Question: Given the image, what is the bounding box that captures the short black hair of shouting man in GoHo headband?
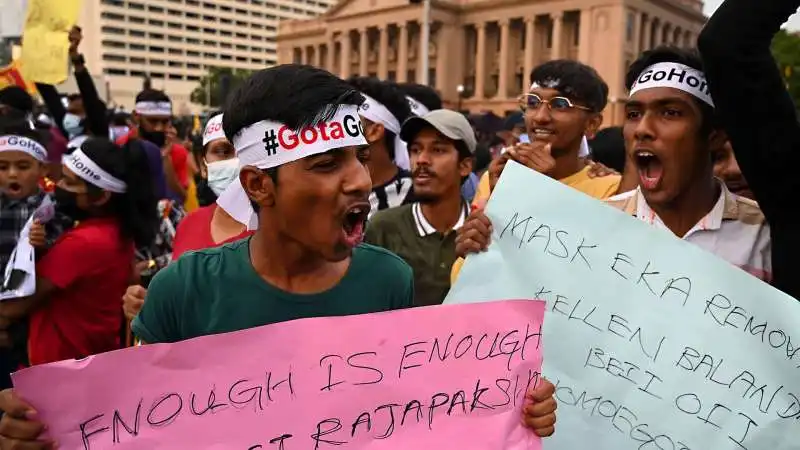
[625,45,722,136]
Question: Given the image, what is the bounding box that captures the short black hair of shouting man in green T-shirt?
[222,64,364,185]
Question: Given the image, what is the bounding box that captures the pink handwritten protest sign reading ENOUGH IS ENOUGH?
[13,300,544,450]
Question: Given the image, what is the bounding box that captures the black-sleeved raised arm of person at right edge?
[698,0,800,299]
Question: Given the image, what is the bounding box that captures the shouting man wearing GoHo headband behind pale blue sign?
[609,47,772,281]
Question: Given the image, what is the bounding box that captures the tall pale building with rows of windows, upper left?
[78,0,334,114]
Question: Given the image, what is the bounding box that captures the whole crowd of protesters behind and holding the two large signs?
[0,0,800,449]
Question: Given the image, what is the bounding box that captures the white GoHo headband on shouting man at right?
[630,62,714,107]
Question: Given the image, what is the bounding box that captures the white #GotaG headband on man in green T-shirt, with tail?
[217,105,368,230]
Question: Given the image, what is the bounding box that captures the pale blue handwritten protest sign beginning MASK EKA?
[445,163,800,450]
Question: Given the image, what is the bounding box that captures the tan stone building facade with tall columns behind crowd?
[278,0,706,125]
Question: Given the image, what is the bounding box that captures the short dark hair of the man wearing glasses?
[530,59,608,113]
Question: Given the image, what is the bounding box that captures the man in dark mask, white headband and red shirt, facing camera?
[117,89,189,204]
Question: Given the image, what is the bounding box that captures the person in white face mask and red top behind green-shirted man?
[122,114,252,320]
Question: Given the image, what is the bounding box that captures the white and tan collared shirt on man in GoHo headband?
[606,183,772,282]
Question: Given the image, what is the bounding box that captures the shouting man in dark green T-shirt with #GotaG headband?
[132,65,413,343]
